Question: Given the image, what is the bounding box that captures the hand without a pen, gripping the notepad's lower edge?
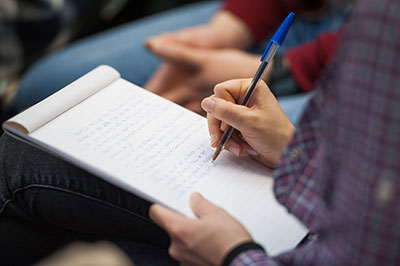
[149,193,251,265]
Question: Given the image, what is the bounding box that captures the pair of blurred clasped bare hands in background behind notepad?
[145,11,272,114]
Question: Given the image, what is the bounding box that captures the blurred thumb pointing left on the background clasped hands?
[147,38,201,66]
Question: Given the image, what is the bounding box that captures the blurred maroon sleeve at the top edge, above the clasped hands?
[223,0,318,42]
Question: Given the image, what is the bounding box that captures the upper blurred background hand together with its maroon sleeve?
[148,0,325,49]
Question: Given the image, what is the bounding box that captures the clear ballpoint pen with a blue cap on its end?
[212,12,294,161]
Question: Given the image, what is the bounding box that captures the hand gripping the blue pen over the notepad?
[201,79,295,167]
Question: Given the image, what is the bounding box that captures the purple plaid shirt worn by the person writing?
[231,0,400,266]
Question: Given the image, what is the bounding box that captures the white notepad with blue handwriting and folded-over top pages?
[3,66,307,255]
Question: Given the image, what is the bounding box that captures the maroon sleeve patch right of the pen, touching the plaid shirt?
[285,31,341,91]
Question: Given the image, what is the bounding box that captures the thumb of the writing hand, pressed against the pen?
[201,97,249,131]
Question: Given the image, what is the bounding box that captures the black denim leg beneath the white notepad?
[0,135,169,265]
